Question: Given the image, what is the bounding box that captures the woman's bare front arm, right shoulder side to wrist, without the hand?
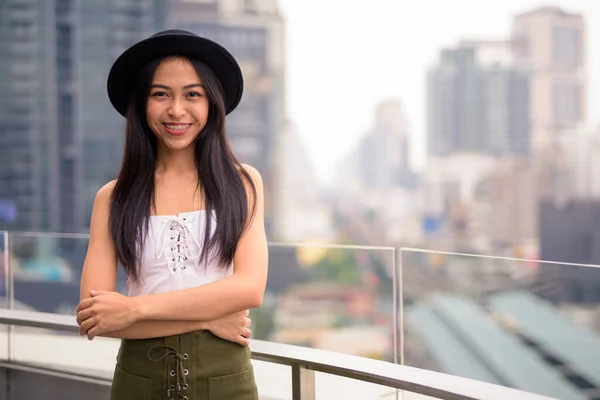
[133,167,268,321]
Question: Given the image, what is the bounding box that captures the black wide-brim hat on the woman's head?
[107,29,244,117]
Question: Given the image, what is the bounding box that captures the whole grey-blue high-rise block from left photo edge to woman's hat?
[0,0,168,232]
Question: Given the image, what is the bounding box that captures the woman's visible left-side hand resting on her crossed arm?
[77,290,137,340]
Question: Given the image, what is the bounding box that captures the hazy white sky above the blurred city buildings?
[279,0,600,184]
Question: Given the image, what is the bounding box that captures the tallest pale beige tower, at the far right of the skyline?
[512,7,587,145]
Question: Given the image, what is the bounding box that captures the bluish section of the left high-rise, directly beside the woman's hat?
[75,0,169,226]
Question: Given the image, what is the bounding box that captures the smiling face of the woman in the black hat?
[146,57,209,150]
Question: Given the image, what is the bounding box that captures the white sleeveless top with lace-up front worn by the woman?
[127,210,233,296]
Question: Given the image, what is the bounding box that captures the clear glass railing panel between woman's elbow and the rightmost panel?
[258,244,397,362]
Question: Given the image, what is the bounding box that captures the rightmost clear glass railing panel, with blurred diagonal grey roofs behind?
[399,250,600,400]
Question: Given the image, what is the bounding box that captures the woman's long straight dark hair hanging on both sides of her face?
[109,57,256,281]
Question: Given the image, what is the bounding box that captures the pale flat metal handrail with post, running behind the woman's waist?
[0,310,551,400]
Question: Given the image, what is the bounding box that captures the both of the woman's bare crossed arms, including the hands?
[77,168,268,341]
